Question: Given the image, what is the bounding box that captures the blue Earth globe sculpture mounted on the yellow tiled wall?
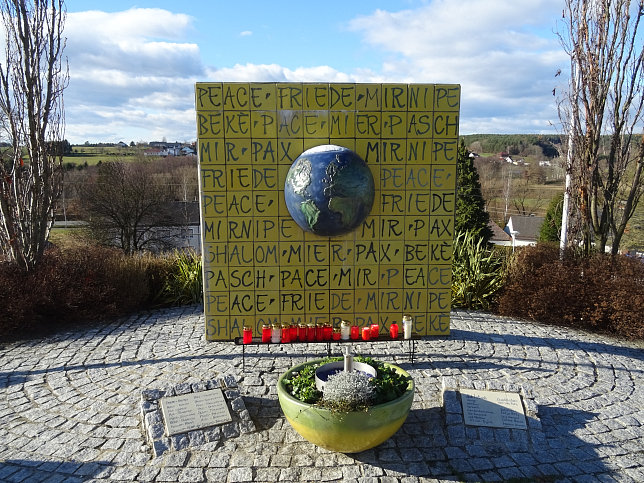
[284,144,374,236]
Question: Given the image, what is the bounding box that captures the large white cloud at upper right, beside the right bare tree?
[349,0,566,132]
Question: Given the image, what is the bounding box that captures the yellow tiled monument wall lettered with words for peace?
[195,82,460,340]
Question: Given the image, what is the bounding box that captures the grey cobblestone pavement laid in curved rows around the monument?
[0,307,644,482]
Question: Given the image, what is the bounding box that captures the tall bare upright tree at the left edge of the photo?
[0,0,69,270]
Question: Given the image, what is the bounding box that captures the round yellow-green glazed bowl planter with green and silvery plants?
[277,357,414,453]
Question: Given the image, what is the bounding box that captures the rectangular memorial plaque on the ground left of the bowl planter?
[161,389,232,436]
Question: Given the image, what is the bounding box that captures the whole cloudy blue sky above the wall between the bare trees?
[65,0,568,143]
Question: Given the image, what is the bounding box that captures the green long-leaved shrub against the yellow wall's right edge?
[452,231,505,310]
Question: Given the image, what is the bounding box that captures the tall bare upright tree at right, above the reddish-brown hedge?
[559,0,644,254]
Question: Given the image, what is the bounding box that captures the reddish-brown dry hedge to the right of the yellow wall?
[498,244,644,339]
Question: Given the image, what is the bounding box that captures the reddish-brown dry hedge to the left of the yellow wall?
[0,245,172,338]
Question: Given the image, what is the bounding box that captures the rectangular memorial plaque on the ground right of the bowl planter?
[460,389,527,429]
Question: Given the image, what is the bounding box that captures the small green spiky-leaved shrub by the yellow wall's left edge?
[160,251,203,305]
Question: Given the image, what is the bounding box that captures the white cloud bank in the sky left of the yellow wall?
[65,8,204,143]
